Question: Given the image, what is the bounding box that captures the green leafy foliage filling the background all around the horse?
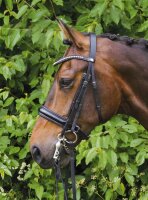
[0,0,148,200]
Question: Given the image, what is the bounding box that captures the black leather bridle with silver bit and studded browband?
[39,33,102,199]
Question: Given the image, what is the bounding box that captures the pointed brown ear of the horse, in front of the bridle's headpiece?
[58,19,89,48]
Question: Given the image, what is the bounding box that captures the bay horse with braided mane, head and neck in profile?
[30,20,148,168]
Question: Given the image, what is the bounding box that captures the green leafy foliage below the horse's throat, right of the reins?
[77,116,148,200]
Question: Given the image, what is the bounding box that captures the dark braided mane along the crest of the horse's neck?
[98,33,148,49]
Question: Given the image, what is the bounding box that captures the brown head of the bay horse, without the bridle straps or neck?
[30,21,148,168]
